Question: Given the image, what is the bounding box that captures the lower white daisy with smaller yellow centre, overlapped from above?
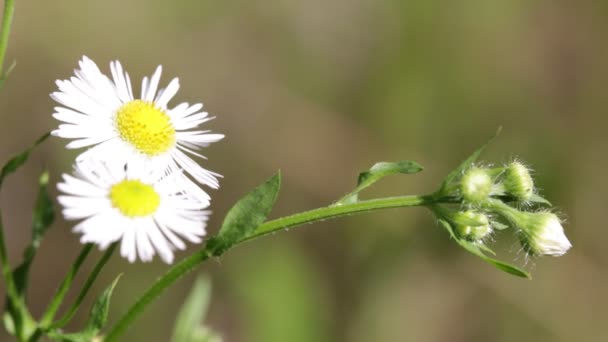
[57,160,209,263]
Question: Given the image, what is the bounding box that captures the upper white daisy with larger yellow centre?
[51,56,224,201]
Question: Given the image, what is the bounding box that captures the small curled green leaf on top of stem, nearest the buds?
[333,160,423,205]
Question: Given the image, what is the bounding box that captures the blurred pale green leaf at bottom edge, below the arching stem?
[171,275,211,342]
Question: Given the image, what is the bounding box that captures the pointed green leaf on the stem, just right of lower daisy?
[205,172,281,256]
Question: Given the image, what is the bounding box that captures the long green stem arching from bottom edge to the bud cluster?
[104,196,444,342]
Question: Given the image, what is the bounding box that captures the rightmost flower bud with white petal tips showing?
[517,212,572,256]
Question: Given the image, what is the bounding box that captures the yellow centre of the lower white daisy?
[110,180,160,217]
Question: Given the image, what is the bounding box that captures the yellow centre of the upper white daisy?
[116,100,175,156]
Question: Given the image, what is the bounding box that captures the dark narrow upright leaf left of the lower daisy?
[13,171,55,295]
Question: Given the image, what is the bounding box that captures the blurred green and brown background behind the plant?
[0,0,608,342]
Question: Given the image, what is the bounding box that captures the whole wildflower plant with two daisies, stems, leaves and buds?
[0,0,571,342]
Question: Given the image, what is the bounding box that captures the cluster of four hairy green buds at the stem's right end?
[441,161,572,256]
